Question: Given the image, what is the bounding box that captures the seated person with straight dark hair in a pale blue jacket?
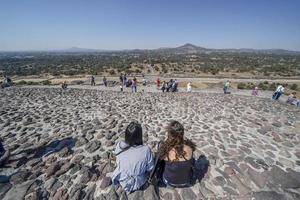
[112,122,154,193]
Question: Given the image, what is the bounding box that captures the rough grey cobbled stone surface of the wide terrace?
[0,86,300,200]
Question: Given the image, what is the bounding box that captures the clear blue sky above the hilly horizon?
[0,0,300,51]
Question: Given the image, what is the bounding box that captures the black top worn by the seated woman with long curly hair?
[163,158,194,185]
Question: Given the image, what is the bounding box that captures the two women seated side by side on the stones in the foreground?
[112,120,209,193]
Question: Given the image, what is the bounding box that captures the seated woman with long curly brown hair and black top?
[160,120,203,187]
